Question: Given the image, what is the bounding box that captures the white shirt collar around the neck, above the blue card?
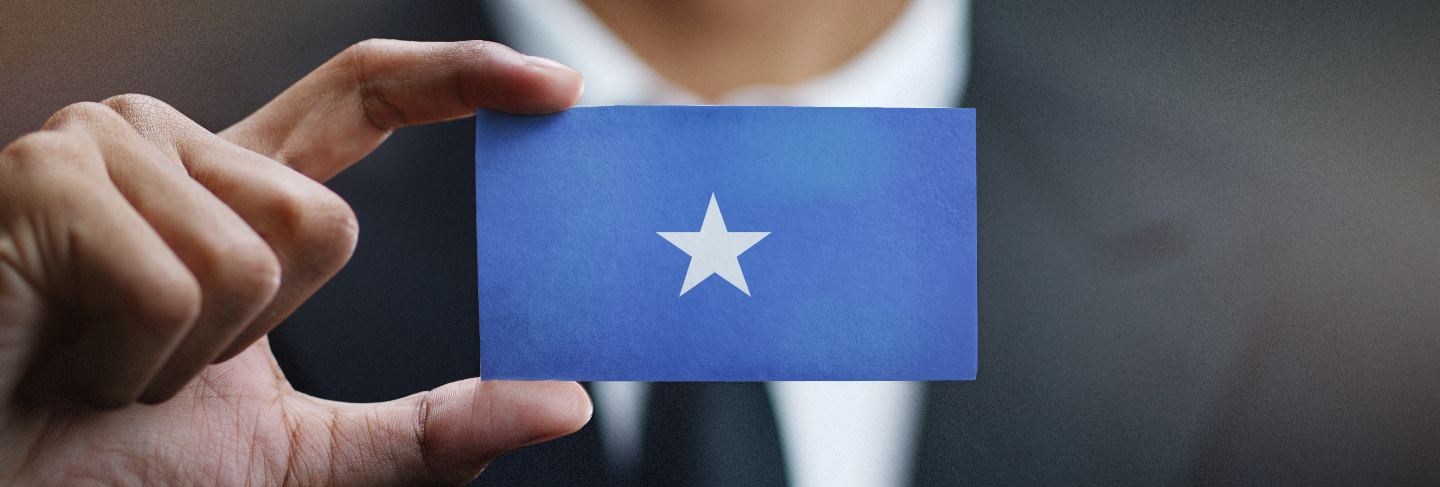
[492,0,969,107]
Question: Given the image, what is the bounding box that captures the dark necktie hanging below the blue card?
[634,382,786,487]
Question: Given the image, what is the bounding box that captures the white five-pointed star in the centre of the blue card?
[655,193,770,295]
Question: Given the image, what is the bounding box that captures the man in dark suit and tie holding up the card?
[0,1,1440,486]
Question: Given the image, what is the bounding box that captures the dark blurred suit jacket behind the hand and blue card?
[160,0,1440,486]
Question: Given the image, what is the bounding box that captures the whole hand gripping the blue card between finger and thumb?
[0,40,590,486]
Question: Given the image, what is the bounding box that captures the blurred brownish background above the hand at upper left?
[0,0,475,136]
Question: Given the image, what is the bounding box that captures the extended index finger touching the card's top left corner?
[220,39,583,180]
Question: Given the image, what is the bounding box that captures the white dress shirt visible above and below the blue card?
[492,0,969,487]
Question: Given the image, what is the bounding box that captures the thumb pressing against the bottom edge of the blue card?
[308,379,592,486]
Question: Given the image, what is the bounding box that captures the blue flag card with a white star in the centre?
[475,107,976,380]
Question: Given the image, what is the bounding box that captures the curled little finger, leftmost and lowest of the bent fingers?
[4,130,200,406]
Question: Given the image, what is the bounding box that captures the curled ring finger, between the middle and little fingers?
[50,95,281,403]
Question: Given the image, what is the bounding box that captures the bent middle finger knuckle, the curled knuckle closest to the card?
[275,183,360,274]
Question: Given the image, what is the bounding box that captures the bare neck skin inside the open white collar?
[582,0,907,101]
